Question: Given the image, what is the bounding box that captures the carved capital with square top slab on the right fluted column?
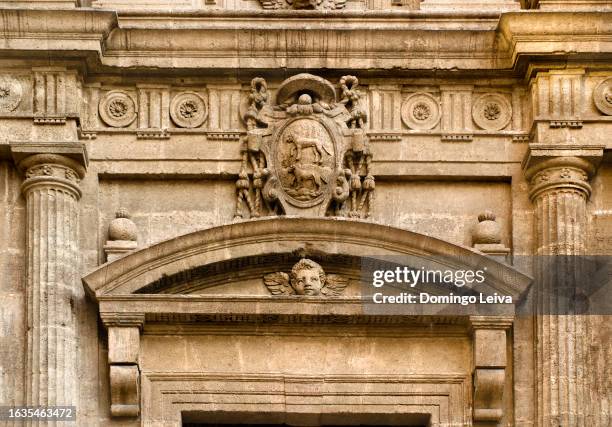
[523,144,604,200]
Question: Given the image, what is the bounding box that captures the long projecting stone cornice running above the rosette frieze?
[0,9,612,74]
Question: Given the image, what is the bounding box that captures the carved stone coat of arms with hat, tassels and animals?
[236,74,375,218]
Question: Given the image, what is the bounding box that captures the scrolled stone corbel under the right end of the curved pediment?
[470,316,512,423]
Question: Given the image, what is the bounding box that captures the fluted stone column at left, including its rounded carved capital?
[19,154,85,424]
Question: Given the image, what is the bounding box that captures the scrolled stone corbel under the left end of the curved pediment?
[100,313,144,417]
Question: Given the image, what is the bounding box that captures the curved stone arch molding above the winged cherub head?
[83,217,529,301]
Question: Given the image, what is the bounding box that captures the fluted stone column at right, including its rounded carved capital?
[525,156,599,427]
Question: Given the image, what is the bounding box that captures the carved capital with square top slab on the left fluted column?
[10,142,88,200]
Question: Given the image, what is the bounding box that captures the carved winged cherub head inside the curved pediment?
[264,259,348,296]
